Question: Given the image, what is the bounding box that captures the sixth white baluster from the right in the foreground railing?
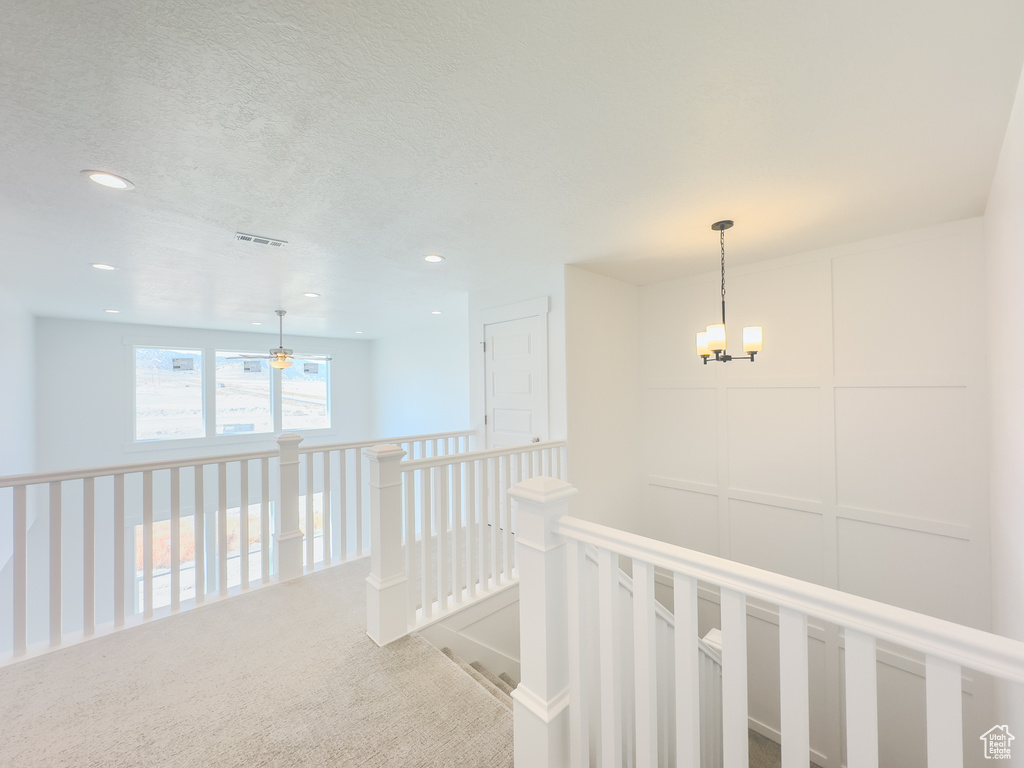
[633,559,657,768]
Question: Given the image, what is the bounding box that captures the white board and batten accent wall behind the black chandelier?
[634,219,990,766]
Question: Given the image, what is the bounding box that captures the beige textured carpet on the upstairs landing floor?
[0,559,512,768]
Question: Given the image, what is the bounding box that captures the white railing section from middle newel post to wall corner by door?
[366,440,567,645]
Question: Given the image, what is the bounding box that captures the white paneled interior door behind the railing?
[483,315,548,447]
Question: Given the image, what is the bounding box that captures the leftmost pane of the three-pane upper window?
[135,347,206,440]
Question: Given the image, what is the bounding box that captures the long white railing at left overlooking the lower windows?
[0,431,472,664]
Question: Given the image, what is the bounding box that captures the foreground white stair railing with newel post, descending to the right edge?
[510,477,1024,768]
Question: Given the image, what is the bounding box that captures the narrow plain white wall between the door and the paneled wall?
[565,266,641,530]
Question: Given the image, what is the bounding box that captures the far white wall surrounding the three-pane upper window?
[36,317,374,471]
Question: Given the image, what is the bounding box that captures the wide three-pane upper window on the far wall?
[132,345,331,442]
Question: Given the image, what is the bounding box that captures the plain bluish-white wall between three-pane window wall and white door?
[370,298,470,437]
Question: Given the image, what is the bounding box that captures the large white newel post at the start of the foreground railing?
[509,477,578,768]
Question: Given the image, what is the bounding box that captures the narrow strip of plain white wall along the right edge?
[985,60,1024,738]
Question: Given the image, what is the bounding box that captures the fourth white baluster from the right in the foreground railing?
[722,588,749,768]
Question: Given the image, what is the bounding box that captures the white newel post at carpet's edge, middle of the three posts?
[365,445,409,645]
